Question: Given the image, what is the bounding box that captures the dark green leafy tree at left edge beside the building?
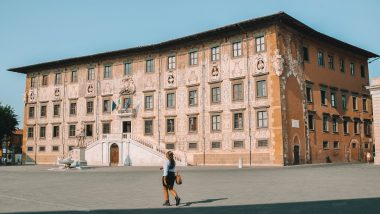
[0,103,18,142]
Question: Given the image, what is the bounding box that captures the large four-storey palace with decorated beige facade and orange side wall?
[9,12,378,165]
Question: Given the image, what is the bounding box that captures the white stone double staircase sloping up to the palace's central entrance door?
[86,133,187,166]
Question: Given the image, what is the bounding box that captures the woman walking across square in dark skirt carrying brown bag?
[162,151,181,206]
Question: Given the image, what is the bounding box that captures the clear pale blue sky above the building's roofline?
[0,0,380,127]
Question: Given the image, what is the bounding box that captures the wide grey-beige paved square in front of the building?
[0,164,380,214]
